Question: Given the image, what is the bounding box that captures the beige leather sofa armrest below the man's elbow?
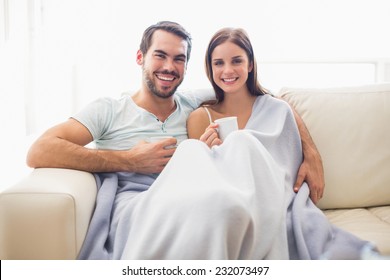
[0,168,97,259]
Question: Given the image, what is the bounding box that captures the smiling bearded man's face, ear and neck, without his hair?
[132,30,188,122]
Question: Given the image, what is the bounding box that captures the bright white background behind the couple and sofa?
[0,0,390,188]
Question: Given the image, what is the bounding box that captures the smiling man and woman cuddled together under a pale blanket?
[28,21,374,259]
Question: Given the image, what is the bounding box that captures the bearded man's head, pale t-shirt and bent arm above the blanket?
[27,22,201,174]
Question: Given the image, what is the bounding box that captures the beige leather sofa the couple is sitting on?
[0,84,390,259]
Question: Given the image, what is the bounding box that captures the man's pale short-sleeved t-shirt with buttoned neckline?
[73,92,209,150]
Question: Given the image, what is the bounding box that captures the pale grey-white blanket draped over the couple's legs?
[79,96,372,259]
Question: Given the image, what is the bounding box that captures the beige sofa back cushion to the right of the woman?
[279,84,390,209]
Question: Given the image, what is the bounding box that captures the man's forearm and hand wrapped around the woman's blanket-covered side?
[292,108,325,203]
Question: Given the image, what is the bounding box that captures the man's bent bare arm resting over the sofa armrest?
[27,119,175,173]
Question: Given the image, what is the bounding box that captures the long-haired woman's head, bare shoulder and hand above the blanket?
[187,28,267,147]
